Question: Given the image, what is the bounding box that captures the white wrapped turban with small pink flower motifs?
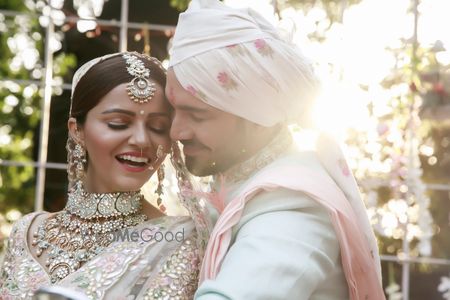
[169,0,317,127]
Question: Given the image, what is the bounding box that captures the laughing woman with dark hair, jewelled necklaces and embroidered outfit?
[0,52,208,299]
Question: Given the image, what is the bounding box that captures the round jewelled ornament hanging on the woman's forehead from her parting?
[122,53,156,103]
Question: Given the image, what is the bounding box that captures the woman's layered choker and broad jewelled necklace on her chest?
[32,181,147,283]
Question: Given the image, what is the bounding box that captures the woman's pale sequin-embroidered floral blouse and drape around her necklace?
[0,212,199,300]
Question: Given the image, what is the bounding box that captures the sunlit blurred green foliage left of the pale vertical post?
[0,0,43,218]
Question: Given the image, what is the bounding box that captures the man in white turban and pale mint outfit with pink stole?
[166,0,384,300]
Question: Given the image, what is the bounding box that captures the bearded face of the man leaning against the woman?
[166,69,249,176]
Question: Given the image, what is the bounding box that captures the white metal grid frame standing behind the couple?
[0,0,450,300]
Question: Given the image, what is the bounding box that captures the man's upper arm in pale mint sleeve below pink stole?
[195,193,348,300]
